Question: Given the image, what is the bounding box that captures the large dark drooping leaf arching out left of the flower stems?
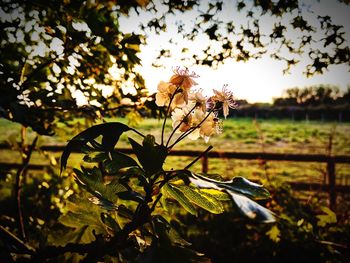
[61,122,130,173]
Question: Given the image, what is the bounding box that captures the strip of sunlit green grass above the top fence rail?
[0,119,350,155]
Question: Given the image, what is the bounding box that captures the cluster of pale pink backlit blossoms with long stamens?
[156,67,235,145]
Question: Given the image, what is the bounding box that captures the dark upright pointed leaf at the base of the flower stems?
[129,135,168,175]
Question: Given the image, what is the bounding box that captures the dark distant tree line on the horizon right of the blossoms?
[232,85,350,122]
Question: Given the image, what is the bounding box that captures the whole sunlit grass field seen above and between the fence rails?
[0,119,350,190]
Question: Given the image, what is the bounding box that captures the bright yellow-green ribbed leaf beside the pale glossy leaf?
[174,185,224,214]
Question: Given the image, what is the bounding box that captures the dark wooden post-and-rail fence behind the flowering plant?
[0,144,350,209]
